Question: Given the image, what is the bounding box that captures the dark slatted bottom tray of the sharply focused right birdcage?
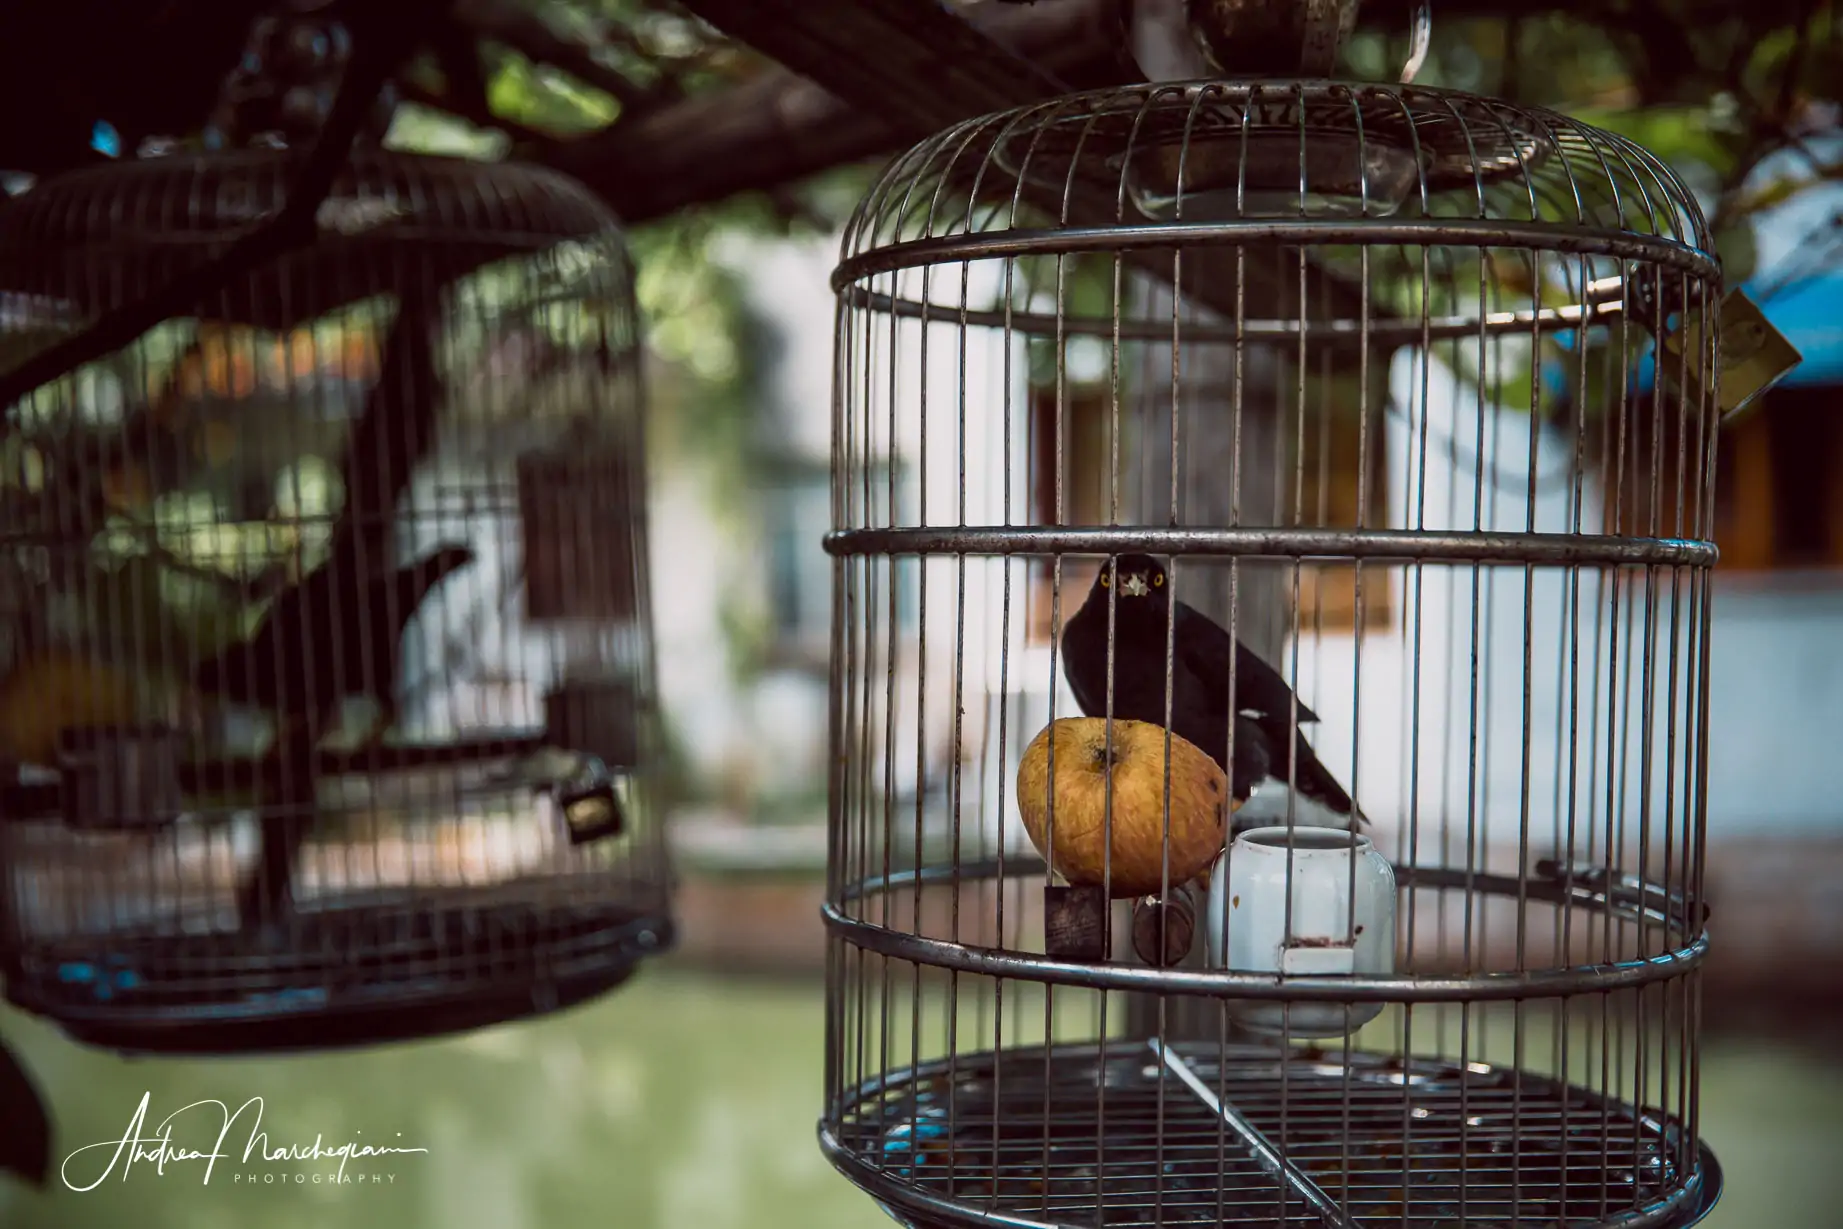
[820,1041,1721,1229]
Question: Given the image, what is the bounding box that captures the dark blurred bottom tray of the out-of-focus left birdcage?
[6,890,673,1054]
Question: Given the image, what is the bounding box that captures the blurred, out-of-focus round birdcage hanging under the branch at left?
[0,149,673,1050]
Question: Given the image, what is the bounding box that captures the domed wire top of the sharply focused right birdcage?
[837,81,1716,341]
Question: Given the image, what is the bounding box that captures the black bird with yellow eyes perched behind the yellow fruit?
[1062,555,1362,822]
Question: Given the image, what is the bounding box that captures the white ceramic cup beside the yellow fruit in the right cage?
[1205,827,1395,1037]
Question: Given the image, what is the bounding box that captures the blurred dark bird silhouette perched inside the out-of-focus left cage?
[192,545,474,732]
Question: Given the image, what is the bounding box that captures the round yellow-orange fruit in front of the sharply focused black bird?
[1017,717,1235,897]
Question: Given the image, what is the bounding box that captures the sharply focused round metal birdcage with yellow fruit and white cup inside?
[820,81,1721,1229]
